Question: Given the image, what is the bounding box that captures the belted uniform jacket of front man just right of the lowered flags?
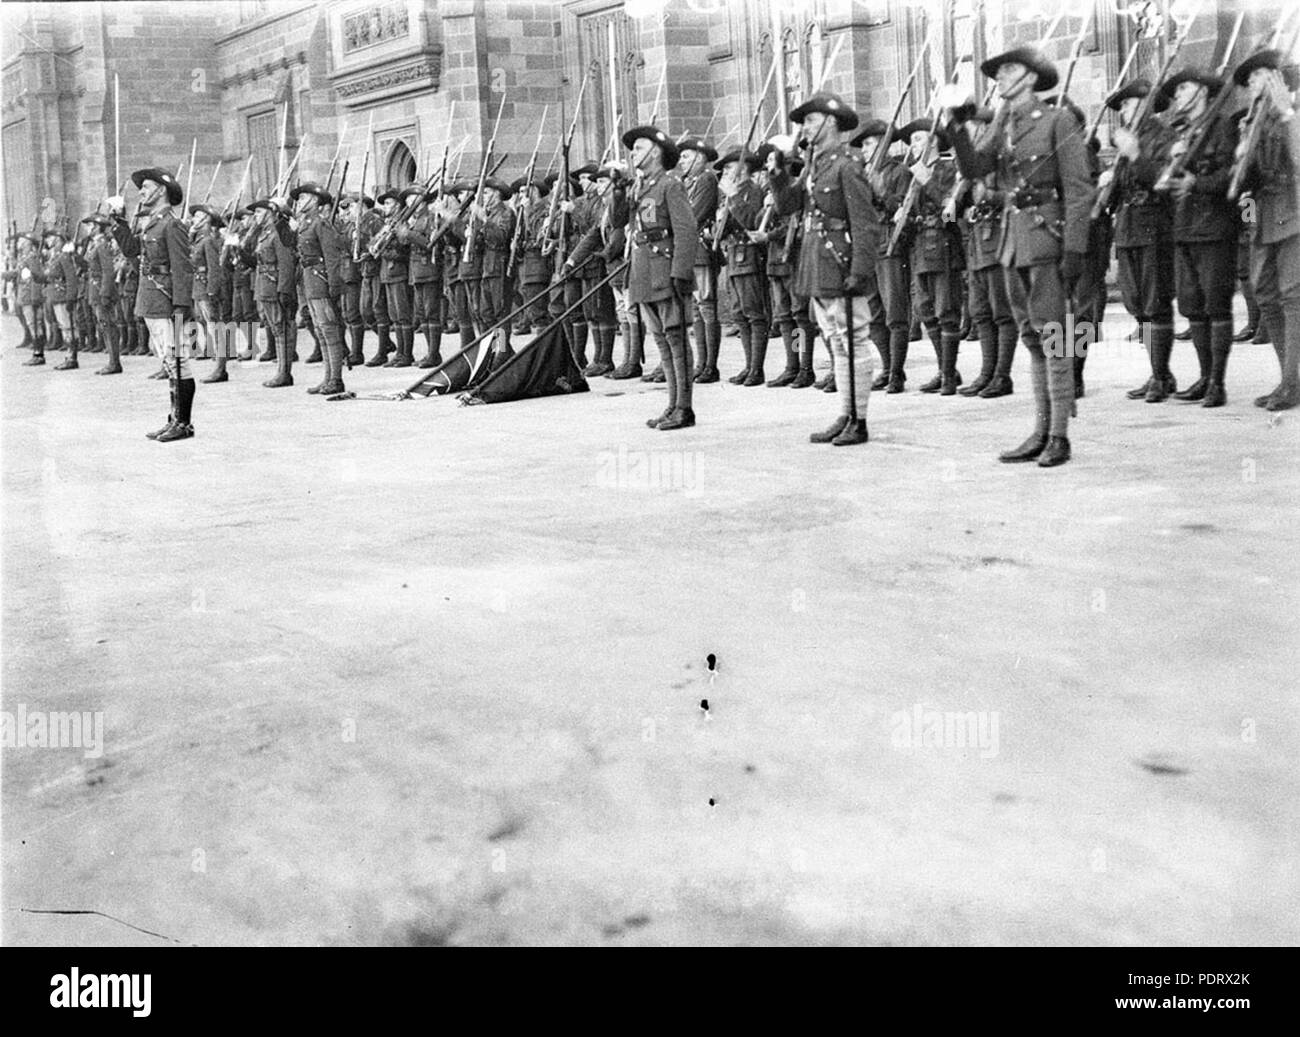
[628,170,699,303]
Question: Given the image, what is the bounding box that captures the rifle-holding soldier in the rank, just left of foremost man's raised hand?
[894,118,963,396]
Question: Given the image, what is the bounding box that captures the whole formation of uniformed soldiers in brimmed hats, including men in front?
[5,30,1300,467]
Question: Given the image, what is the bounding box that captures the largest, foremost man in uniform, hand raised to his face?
[944,47,1092,468]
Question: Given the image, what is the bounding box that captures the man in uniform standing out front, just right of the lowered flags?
[623,126,699,431]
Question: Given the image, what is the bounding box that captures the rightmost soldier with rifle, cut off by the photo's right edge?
[1232,51,1300,411]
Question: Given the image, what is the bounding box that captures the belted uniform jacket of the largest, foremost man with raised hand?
[953,97,1093,266]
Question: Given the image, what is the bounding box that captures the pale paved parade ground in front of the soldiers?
[0,316,1300,945]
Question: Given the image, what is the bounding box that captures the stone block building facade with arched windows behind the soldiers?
[0,0,1282,225]
